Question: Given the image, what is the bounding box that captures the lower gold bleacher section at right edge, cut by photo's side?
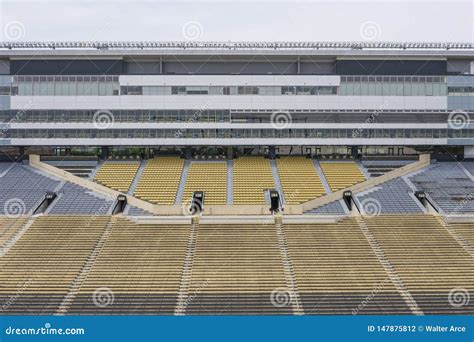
[365,215,474,315]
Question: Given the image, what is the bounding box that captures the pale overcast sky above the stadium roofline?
[0,0,474,42]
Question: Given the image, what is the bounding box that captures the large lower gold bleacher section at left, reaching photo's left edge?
[0,216,110,315]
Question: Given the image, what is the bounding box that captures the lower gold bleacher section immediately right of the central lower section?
[284,219,410,315]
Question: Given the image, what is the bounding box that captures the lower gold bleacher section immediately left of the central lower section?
[68,219,191,315]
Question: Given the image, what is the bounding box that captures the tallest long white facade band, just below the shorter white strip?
[11,95,447,110]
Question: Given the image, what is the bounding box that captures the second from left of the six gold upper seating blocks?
[134,157,184,205]
